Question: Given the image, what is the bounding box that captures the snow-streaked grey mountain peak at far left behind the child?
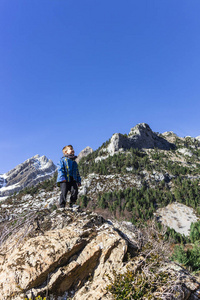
[0,155,56,197]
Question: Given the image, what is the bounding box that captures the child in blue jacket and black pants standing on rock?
[57,145,81,207]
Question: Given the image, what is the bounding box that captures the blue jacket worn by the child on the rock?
[57,156,81,186]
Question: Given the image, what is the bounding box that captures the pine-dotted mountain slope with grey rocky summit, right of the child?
[79,123,200,233]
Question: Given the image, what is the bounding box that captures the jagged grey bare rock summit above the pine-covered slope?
[107,123,175,154]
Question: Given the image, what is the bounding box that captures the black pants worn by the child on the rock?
[60,180,78,207]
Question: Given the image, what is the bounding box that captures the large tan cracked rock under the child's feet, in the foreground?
[0,209,137,300]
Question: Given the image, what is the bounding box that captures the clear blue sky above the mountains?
[0,0,200,173]
